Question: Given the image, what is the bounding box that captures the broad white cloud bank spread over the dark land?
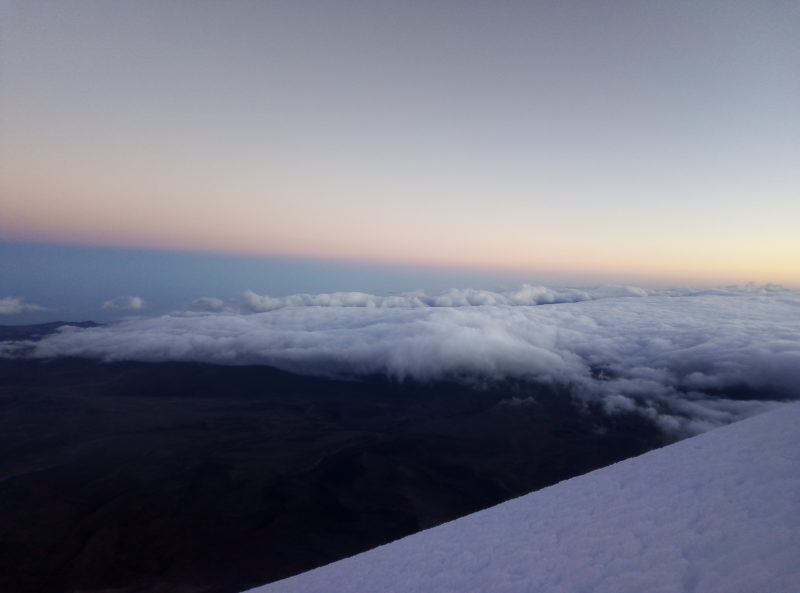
[0,286,800,433]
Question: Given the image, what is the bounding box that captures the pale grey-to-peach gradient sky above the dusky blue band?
[0,0,800,286]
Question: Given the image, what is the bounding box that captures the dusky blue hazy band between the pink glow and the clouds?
[0,243,585,323]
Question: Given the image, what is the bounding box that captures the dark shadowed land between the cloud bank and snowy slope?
[0,358,665,593]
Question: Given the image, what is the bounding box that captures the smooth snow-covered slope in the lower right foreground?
[247,404,800,593]
